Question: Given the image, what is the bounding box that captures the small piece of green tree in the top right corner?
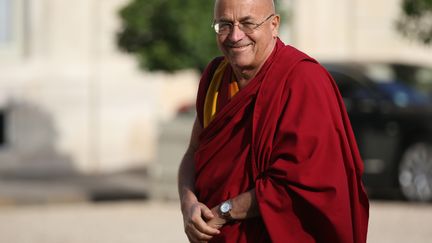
[396,0,432,44]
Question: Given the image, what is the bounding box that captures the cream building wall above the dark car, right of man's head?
[283,0,432,65]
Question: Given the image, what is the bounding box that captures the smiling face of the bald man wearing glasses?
[214,0,279,73]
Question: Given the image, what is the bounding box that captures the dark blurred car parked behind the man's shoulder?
[323,62,432,201]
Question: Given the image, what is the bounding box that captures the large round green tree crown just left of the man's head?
[117,0,219,72]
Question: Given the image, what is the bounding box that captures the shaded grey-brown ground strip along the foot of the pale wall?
[0,169,149,205]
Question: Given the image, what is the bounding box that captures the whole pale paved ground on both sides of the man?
[0,201,432,243]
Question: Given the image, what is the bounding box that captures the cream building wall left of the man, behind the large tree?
[0,0,198,173]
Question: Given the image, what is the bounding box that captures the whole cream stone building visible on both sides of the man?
[0,0,432,174]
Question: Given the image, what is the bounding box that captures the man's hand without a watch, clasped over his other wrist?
[182,196,220,242]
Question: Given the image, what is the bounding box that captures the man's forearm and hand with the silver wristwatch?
[207,189,260,228]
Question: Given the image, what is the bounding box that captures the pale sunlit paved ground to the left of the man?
[0,201,186,243]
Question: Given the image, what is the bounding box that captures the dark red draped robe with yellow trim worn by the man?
[195,40,369,243]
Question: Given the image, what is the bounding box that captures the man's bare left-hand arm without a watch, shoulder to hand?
[178,119,219,242]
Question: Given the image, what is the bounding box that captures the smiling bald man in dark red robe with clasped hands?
[178,0,369,243]
